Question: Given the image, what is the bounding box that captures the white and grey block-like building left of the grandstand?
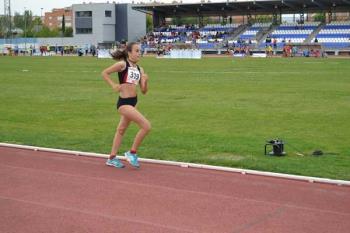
[72,3,146,45]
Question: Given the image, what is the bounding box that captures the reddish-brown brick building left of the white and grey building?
[44,7,73,29]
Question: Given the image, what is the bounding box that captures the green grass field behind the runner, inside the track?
[0,57,350,180]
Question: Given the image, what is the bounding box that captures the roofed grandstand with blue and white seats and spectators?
[133,0,350,54]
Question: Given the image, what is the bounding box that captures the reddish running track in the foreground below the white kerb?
[0,147,350,233]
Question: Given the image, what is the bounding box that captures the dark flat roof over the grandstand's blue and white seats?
[132,0,350,17]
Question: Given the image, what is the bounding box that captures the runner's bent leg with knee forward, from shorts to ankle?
[119,105,151,151]
